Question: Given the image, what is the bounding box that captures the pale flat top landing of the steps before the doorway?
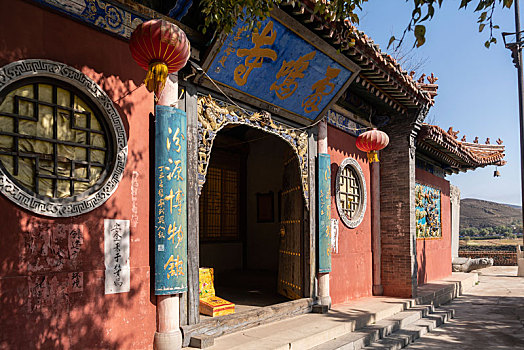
[186,273,478,350]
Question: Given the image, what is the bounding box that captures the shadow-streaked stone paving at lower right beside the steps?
[406,266,524,350]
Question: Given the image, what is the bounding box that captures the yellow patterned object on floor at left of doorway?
[198,267,235,317]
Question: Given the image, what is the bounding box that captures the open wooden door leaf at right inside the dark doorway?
[277,153,304,299]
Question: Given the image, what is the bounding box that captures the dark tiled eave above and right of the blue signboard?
[280,0,438,114]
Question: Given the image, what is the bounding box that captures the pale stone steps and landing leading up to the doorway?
[184,273,478,350]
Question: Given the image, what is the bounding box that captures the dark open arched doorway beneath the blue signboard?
[199,125,304,313]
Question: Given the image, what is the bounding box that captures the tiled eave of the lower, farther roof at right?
[417,124,506,173]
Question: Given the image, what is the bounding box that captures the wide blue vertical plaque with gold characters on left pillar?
[155,106,187,295]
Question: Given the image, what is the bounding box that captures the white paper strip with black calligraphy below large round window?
[104,219,130,294]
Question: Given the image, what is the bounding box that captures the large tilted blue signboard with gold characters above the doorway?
[207,17,352,120]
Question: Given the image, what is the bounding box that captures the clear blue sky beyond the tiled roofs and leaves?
[359,0,524,205]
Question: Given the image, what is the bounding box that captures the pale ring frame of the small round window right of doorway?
[335,158,367,228]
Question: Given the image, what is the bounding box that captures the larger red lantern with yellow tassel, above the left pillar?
[129,19,191,95]
